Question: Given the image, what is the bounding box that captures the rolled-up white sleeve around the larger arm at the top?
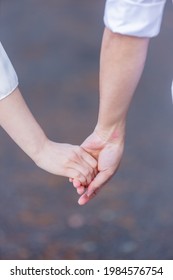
[104,0,166,37]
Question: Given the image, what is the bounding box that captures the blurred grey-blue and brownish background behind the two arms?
[0,0,173,260]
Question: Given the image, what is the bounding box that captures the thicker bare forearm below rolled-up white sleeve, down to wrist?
[96,28,149,140]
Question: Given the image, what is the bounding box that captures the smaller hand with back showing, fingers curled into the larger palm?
[35,138,97,185]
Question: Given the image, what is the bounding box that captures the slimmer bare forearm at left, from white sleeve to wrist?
[0,88,47,161]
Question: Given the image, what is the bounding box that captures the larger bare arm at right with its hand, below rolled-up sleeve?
[73,28,149,205]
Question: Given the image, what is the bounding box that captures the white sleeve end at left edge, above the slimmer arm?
[0,42,18,100]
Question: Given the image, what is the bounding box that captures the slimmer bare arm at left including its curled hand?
[0,88,97,185]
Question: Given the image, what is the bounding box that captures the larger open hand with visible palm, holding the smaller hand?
[73,131,124,205]
